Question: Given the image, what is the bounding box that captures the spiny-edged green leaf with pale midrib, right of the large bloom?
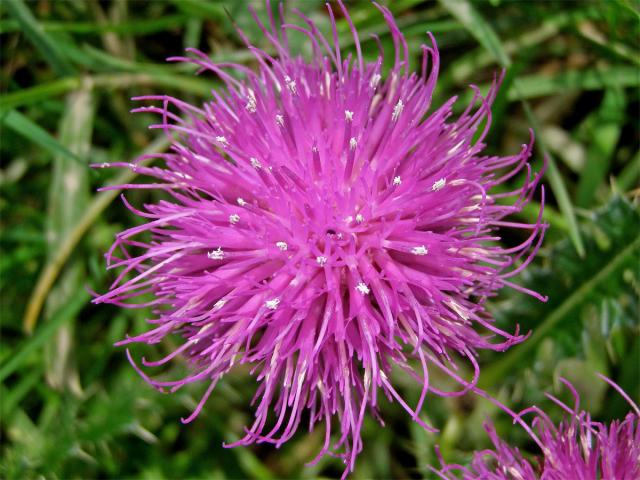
[481,197,640,386]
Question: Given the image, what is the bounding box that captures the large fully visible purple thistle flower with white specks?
[94,3,546,473]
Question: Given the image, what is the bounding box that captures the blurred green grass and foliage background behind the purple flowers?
[0,0,640,479]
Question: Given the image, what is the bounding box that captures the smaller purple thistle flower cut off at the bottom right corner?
[434,375,640,480]
